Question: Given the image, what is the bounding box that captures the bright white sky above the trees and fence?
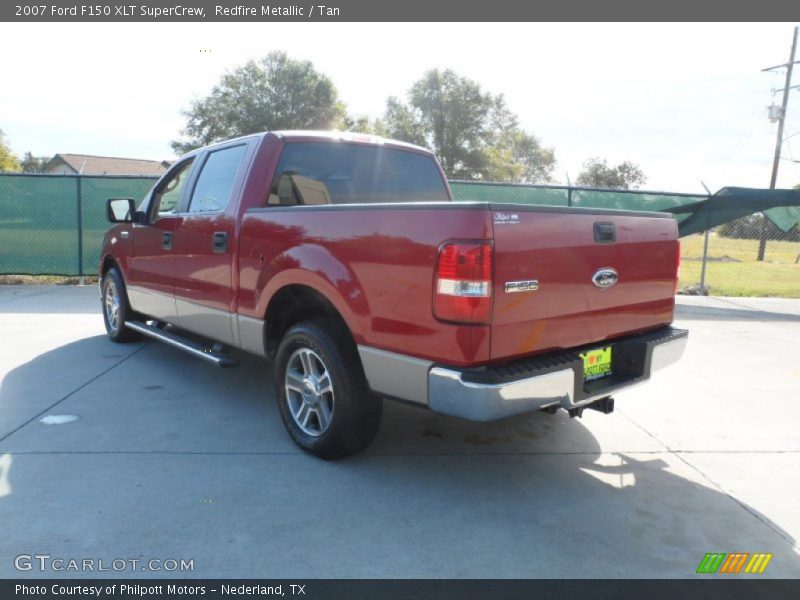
[0,23,800,192]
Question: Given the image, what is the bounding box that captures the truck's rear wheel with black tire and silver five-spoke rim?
[274,319,383,459]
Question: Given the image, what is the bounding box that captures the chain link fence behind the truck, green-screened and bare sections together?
[0,174,800,298]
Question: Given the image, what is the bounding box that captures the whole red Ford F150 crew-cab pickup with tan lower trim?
[100,131,687,458]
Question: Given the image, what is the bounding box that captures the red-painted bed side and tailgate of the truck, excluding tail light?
[238,202,678,366]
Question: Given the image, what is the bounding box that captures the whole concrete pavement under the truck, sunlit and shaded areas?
[0,286,800,578]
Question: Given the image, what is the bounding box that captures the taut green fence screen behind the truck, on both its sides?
[0,173,792,276]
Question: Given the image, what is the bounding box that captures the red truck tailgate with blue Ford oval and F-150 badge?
[490,205,679,360]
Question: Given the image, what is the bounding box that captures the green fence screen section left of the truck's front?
[0,174,155,275]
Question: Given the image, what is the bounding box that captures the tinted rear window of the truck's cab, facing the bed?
[267,142,450,206]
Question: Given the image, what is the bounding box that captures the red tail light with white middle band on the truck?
[433,242,492,323]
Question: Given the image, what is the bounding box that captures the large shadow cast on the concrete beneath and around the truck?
[0,336,800,577]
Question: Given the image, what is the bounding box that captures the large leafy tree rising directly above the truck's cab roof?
[172,52,345,154]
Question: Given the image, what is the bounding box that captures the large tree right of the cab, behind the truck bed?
[377,69,555,182]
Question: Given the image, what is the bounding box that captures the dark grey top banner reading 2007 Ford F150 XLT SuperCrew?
[0,0,800,23]
